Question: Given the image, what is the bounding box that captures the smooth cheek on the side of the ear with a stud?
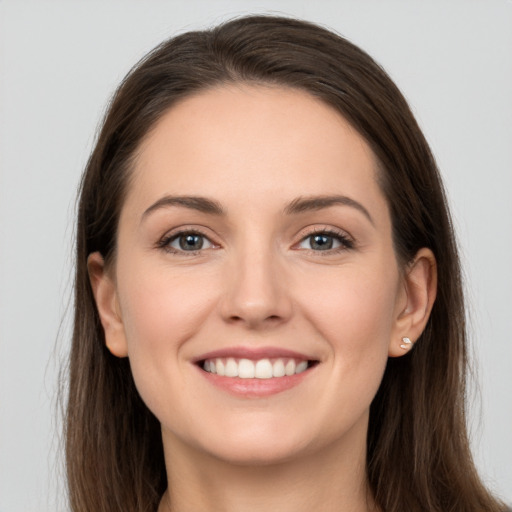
[294,266,399,406]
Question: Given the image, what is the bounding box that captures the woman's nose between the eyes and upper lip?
[221,246,293,330]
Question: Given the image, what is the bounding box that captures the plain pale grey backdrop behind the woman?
[0,0,512,512]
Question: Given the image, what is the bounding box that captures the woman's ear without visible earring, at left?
[87,252,128,357]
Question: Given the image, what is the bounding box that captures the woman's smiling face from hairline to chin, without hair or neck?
[93,85,416,463]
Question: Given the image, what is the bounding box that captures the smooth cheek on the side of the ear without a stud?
[114,266,218,416]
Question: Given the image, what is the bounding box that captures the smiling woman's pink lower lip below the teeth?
[198,366,315,398]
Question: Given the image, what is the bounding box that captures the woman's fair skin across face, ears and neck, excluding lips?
[89,85,436,512]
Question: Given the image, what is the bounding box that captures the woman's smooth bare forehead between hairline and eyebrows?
[129,85,382,216]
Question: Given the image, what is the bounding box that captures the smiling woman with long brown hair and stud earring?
[66,17,503,512]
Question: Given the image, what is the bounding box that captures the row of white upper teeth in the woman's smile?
[203,357,308,379]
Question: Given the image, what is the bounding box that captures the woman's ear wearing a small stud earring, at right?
[389,248,437,357]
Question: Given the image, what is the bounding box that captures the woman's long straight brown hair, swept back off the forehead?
[66,16,502,512]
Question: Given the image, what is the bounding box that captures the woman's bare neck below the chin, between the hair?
[158,424,377,512]
